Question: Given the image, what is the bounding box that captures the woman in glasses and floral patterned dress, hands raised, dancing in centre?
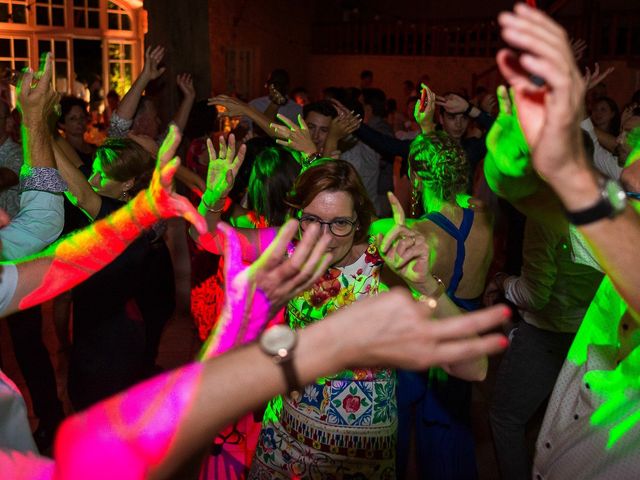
[190,137,448,478]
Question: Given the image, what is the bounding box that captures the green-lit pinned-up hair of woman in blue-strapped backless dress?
[409,131,469,206]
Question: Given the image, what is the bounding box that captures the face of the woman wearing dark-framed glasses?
[301,191,358,266]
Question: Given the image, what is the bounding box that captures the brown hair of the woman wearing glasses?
[287,158,374,243]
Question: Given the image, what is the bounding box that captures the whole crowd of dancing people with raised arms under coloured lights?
[0,5,640,480]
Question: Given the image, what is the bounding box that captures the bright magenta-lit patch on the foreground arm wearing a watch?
[54,364,203,480]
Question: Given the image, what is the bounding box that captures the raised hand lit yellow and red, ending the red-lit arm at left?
[146,124,207,234]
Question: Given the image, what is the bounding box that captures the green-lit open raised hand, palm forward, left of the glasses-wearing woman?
[202,134,247,205]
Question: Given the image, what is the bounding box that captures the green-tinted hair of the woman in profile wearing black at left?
[94,138,155,195]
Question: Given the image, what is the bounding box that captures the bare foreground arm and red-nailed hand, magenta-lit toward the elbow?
[55,291,507,480]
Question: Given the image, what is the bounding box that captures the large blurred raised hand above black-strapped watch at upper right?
[496,4,585,179]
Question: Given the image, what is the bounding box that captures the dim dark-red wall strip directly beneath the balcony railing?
[307,55,640,106]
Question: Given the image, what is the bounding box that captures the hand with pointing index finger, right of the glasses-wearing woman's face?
[378,192,432,294]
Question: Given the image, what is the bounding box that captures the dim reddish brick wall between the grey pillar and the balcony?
[209,0,313,97]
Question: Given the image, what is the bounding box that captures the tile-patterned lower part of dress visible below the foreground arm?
[249,372,397,480]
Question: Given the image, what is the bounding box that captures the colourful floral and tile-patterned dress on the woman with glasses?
[249,243,397,480]
